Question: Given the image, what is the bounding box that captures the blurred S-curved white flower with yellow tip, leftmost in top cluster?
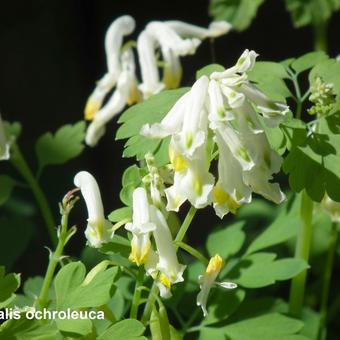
[85,15,135,120]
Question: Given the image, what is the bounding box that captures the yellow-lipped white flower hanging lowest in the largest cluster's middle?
[213,131,251,218]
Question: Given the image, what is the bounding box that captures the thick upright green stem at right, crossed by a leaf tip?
[289,191,313,317]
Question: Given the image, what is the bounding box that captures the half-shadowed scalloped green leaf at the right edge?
[283,112,340,202]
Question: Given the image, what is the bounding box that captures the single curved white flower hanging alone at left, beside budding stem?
[74,171,113,248]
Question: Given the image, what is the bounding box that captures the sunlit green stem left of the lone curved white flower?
[38,207,68,309]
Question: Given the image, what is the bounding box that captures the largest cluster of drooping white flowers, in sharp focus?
[141,50,289,218]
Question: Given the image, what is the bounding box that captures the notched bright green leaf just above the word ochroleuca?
[54,262,118,310]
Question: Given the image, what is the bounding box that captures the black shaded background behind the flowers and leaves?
[0,0,340,277]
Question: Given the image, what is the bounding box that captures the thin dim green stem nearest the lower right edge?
[318,222,338,340]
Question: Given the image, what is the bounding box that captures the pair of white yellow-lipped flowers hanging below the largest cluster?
[125,187,186,298]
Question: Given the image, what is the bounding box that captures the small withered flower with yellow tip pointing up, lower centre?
[196,255,237,316]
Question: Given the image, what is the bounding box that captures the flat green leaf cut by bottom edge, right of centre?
[224,313,303,340]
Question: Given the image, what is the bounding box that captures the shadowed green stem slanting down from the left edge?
[11,143,58,247]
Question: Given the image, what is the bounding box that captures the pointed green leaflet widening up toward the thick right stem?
[246,195,301,254]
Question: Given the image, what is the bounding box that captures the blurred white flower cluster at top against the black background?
[85,15,231,146]
